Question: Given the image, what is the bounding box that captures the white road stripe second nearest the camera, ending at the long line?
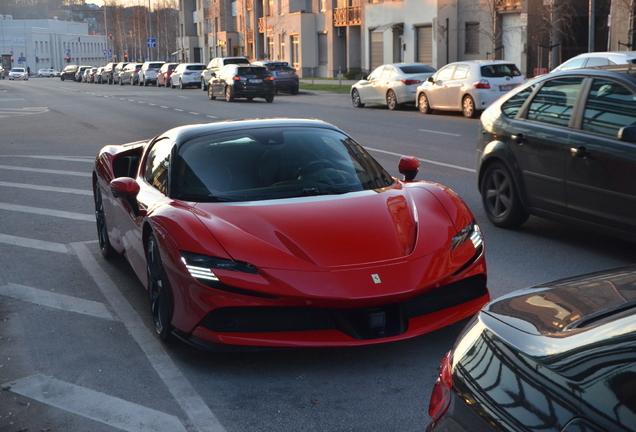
[0,283,115,321]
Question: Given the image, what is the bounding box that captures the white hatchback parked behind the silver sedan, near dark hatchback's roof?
[416,60,526,118]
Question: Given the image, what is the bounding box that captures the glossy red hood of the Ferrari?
[195,187,456,269]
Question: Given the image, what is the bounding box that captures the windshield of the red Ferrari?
[170,127,394,202]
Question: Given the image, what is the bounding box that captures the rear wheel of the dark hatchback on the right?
[481,162,528,228]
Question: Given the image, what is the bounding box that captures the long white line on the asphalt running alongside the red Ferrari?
[70,243,226,432]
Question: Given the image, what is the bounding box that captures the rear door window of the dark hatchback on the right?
[527,78,583,127]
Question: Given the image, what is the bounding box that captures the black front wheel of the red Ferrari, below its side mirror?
[146,234,174,340]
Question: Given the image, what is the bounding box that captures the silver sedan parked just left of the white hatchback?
[351,63,435,110]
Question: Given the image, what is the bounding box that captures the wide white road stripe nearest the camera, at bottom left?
[3,374,186,432]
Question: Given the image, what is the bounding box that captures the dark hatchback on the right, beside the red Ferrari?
[477,65,636,245]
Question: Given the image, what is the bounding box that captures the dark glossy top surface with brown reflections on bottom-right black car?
[484,266,636,338]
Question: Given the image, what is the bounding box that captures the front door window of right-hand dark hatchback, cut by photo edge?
[581,79,636,138]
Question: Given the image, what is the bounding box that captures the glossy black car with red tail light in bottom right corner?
[426,266,636,432]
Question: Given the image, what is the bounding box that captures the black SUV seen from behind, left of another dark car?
[208,64,276,102]
